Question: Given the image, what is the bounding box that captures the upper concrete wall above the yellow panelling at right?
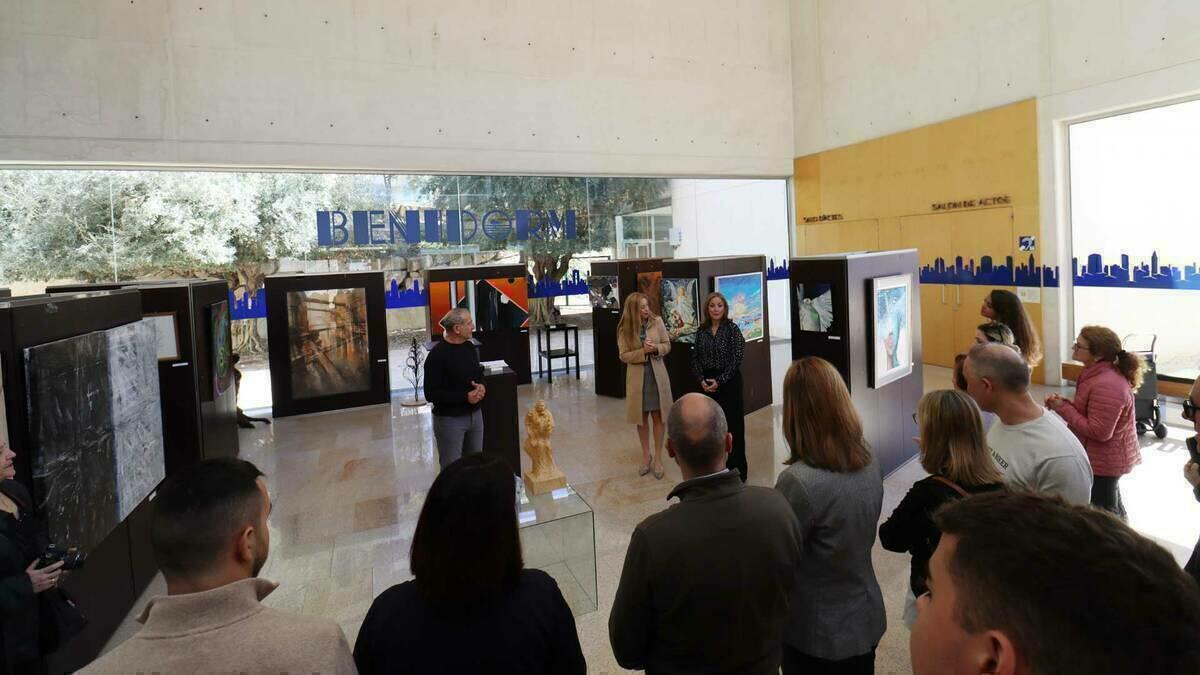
[792,0,1200,156]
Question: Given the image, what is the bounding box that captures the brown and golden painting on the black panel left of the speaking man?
[288,288,371,399]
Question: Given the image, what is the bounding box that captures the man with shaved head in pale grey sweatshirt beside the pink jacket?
[962,342,1092,504]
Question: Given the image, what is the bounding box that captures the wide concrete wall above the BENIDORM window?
[0,0,793,175]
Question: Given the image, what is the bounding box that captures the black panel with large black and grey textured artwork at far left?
[0,289,164,671]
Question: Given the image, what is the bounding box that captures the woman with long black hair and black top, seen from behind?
[354,454,587,675]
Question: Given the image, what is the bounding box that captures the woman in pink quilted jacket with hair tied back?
[1046,325,1146,518]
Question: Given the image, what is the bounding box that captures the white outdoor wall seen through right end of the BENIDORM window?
[671,179,792,338]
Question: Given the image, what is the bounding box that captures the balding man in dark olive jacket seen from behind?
[608,394,800,675]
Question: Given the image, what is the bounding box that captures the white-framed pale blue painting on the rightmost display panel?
[871,274,912,389]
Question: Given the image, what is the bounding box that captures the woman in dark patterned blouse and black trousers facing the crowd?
[691,293,749,483]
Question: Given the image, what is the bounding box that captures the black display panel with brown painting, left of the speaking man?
[266,273,391,417]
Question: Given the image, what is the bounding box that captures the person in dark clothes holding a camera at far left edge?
[0,439,62,675]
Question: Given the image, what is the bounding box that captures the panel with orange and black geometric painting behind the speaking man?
[426,264,533,384]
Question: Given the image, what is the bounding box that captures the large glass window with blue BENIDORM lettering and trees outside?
[0,169,787,410]
